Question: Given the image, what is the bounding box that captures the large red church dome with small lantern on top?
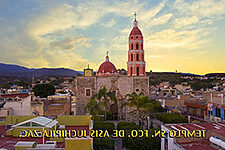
[97,56,118,76]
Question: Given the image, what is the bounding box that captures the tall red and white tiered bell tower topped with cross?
[127,13,146,76]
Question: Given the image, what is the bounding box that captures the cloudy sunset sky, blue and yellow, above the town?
[0,0,225,74]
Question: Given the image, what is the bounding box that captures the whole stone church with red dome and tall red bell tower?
[75,14,149,120]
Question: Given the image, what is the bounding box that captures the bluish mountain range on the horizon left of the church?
[0,63,82,77]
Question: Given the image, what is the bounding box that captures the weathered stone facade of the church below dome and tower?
[75,76,149,120]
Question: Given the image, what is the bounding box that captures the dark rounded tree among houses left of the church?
[32,84,55,98]
